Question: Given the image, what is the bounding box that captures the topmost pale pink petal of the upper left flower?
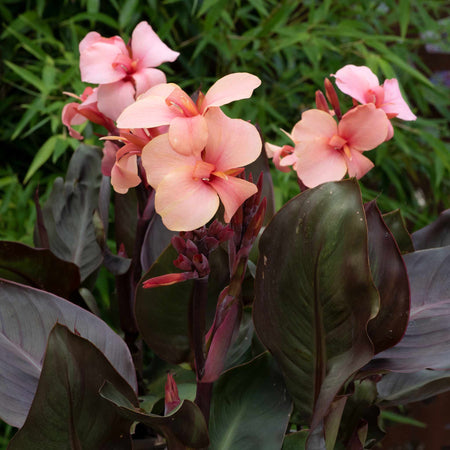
[131,22,180,70]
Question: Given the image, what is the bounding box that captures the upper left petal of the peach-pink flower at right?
[291,109,337,143]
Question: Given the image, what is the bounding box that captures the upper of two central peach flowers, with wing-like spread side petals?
[117,73,261,155]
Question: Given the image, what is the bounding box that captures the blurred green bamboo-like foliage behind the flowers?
[0,0,450,243]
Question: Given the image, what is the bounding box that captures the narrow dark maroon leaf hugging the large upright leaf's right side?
[364,201,410,353]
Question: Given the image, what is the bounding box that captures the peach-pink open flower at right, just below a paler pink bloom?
[288,103,389,187]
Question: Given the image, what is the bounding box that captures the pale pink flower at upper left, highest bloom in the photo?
[80,22,179,120]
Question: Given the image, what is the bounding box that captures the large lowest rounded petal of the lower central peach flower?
[155,166,219,231]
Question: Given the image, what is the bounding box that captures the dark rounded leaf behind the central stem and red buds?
[135,245,229,364]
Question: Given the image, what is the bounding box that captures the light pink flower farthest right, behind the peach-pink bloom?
[333,64,417,120]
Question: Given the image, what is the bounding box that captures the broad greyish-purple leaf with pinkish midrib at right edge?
[367,246,450,372]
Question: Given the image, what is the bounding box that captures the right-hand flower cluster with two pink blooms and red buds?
[266,65,416,187]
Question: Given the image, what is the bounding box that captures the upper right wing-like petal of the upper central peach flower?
[200,72,261,113]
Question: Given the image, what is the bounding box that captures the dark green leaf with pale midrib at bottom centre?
[209,352,292,450]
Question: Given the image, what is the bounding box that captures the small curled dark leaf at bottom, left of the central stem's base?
[100,382,209,450]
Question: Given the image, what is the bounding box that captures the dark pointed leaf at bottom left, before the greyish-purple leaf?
[8,324,138,450]
